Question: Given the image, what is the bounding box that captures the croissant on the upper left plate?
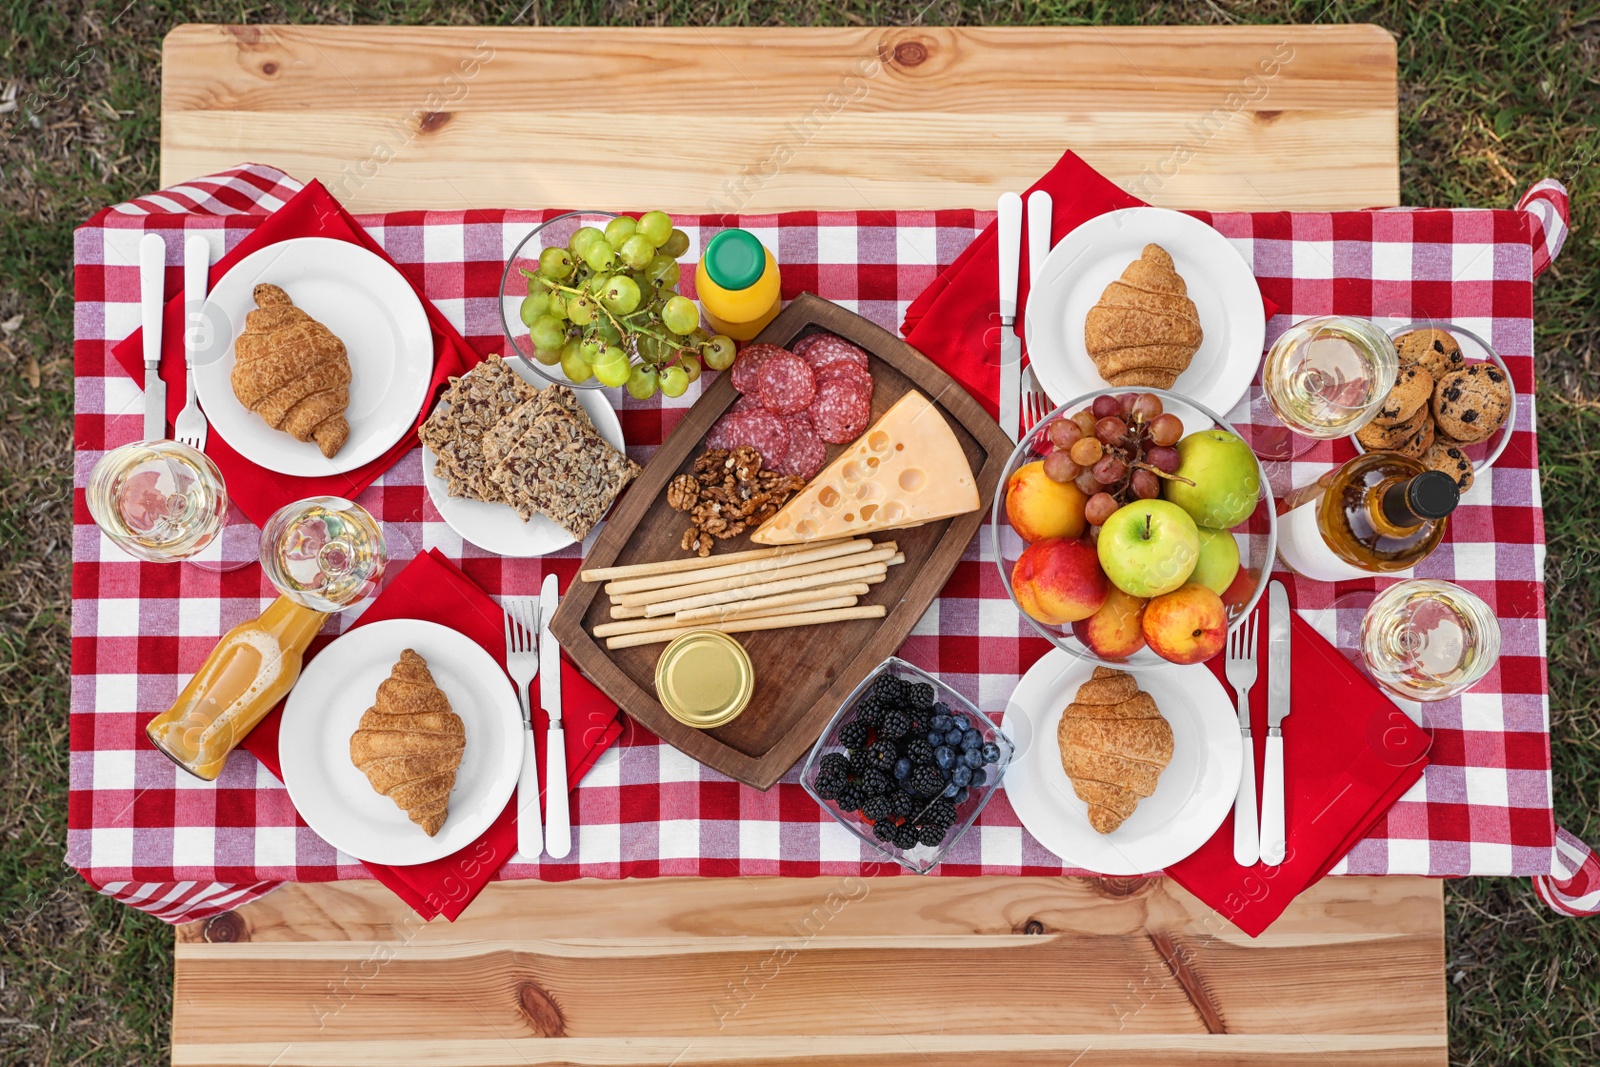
[230,283,350,458]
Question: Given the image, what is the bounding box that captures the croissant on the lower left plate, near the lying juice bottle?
[350,648,467,837]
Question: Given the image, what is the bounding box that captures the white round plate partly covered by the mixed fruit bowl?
[1005,648,1243,875]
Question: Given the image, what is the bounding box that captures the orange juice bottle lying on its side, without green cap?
[144,597,328,782]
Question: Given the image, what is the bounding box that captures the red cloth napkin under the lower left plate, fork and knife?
[243,549,622,920]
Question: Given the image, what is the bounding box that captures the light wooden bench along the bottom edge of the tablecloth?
[173,877,1445,1067]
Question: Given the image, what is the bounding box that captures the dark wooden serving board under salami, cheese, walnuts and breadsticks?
[550,293,1013,789]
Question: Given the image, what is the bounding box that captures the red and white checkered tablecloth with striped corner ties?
[67,166,1600,921]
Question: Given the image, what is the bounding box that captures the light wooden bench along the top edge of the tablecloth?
[162,26,1398,213]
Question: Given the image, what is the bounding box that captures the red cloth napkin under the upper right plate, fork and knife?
[901,152,1278,414]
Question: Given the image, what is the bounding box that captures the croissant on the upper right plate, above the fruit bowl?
[1083,245,1203,389]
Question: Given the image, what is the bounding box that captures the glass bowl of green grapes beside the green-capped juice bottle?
[501,211,734,400]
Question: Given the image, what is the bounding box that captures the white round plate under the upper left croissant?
[194,237,434,478]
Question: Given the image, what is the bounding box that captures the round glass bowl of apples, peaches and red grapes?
[990,389,1277,670]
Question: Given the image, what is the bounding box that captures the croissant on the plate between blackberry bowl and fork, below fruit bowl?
[1056,667,1173,833]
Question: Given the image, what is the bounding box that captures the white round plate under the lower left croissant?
[278,619,523,867]
